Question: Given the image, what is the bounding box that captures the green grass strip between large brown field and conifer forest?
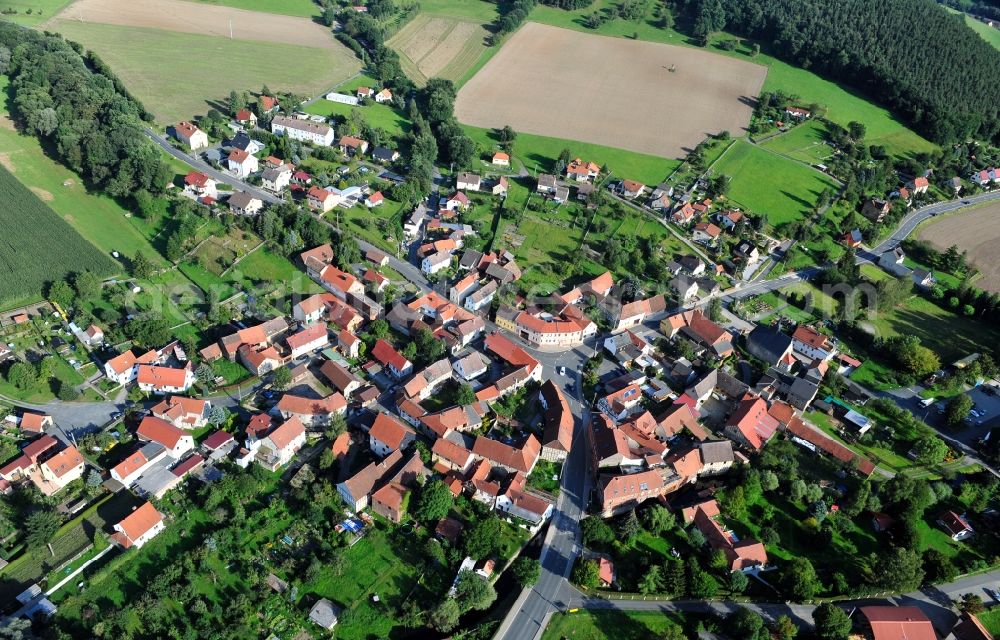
[530,6,936,155]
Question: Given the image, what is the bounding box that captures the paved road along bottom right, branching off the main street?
[566,570,1000,637]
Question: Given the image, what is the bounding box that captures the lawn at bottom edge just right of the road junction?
[542,610,684,640]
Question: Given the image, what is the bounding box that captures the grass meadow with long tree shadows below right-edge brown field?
[870,295,1000,362]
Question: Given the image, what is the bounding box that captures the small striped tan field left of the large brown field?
[388,14,489,85]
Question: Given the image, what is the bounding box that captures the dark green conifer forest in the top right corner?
[678,0,1000,143]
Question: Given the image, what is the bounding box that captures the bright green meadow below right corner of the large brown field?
[713,141,836,227]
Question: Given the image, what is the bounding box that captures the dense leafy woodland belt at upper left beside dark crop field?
[0,23,170,197]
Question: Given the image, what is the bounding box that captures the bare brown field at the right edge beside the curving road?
[920,203,1000,292]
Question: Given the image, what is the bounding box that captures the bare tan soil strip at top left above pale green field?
[50,0,342,48]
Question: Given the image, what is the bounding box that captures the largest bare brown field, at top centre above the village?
[455,22,767,158]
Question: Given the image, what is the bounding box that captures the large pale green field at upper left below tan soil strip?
[52,20,361,123]
